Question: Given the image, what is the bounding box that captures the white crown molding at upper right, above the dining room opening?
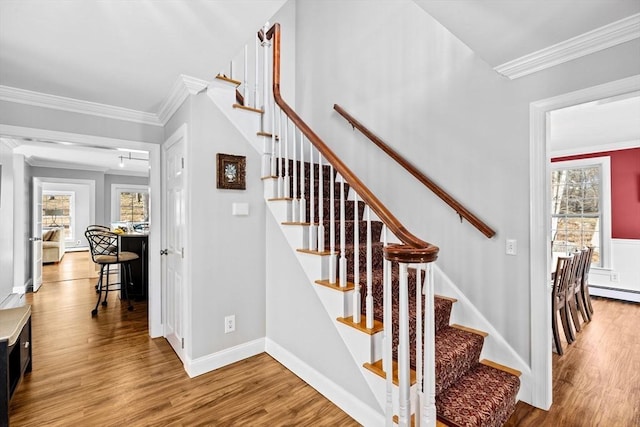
[494,13,640,80]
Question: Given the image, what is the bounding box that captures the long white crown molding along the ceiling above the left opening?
[0,85,163,126]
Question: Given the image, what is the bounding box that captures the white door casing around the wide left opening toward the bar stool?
[0,124,162,338]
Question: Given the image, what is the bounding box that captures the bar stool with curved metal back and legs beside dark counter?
[84,226,138,316]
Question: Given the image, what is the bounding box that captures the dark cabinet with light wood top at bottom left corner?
[0,306,31,427]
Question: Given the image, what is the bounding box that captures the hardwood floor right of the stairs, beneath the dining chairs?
[506,298,640,427]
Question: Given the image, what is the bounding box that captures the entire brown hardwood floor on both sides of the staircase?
[10,252,640,427]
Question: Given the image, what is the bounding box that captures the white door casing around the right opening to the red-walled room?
[529,75,640,409]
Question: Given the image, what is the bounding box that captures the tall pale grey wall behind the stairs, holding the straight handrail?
[296,0,640,361]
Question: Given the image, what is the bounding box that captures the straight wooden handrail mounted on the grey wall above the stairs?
[333,104,496,239]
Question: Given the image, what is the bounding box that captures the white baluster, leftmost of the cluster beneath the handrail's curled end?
[382,225,394,427]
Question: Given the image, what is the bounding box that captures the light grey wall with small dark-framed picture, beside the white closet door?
[165,93,265,364]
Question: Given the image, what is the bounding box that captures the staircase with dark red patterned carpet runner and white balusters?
[208,22,520,427]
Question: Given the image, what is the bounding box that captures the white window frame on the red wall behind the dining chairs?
[549,156,611,270]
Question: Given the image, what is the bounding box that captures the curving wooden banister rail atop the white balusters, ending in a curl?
[266,23,439,262]
